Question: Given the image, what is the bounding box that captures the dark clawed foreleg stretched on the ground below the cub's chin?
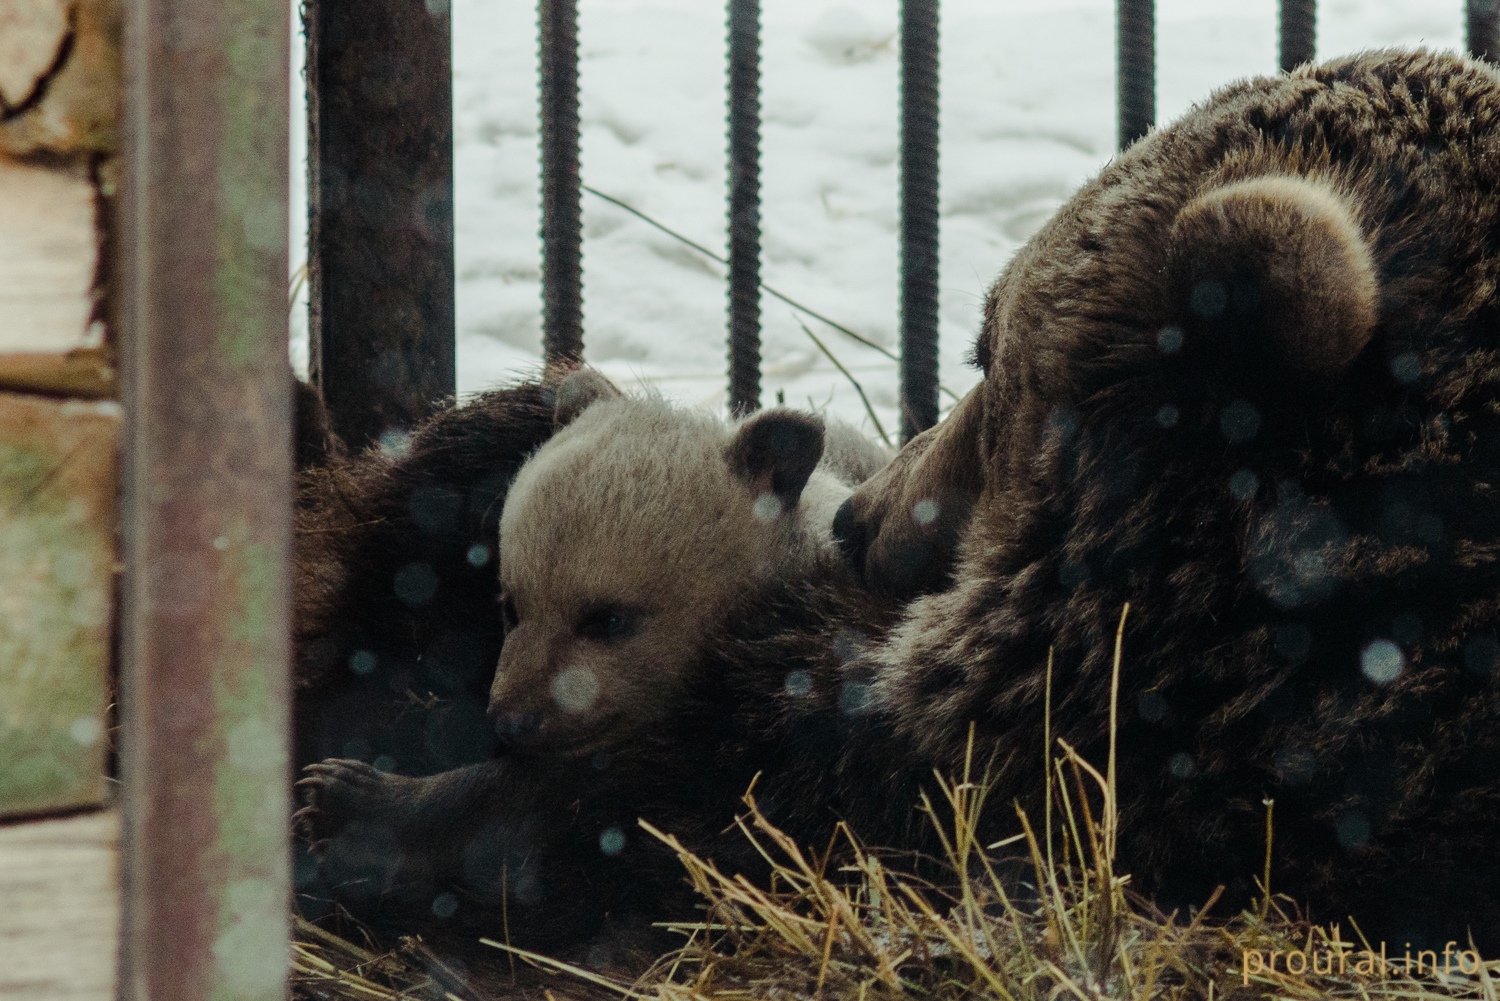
[294,758,683,956]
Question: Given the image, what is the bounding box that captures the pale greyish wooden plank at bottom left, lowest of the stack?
[0,810,120,1001]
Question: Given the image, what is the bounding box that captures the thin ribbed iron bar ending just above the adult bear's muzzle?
[900,0,938,441]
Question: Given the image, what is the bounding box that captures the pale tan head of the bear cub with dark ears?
[489,369,848,756]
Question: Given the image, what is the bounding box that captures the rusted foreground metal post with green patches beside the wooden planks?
[119,0,291,1001]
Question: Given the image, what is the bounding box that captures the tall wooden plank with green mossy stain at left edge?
[0,393,120,816]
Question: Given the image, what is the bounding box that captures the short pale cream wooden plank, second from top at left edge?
[0,158,104,354]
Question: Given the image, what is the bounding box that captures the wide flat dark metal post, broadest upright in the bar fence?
[306,0,455,447]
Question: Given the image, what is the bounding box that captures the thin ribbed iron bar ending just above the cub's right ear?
[729,0,761,414]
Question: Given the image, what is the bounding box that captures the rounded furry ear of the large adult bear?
[1169,177,1380,375]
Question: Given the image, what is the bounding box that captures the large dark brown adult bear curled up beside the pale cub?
[303,53,1500,954]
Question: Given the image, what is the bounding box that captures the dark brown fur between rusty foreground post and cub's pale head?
[294,386,552,774]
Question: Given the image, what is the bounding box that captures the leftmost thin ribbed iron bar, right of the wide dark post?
[537,0,584,365]
